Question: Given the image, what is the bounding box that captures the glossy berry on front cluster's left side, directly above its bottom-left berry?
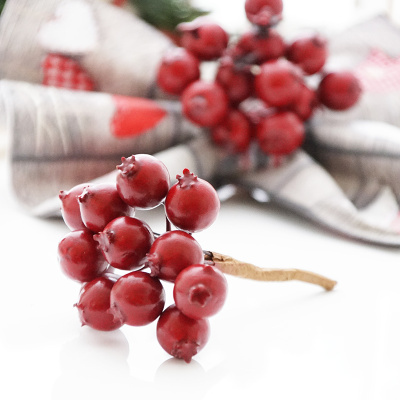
[58,229,107,282]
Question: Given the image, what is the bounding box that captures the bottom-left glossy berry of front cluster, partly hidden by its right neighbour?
[75,274,124,331]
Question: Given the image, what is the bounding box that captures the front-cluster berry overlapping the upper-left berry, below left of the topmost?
[78,183,133,232]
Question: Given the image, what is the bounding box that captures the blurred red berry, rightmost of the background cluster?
[318,71,362,111]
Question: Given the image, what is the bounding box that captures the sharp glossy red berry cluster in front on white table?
[58,154,227,362]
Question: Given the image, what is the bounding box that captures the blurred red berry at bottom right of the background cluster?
[257,112,304,156]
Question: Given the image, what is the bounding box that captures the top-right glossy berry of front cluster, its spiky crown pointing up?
[165,169,220,232]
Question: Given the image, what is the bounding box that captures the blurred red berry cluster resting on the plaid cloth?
[157,0,361,156]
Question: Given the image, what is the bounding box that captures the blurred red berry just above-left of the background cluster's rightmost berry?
[286,35,328,75]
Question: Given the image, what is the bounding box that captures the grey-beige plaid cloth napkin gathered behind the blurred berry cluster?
[0,0,400,246]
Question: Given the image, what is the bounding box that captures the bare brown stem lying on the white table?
[204,251,336,290]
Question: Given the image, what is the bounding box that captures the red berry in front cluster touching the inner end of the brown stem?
[146,231,204,282]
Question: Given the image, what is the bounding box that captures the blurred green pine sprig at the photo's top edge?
[129,0,208,31]
